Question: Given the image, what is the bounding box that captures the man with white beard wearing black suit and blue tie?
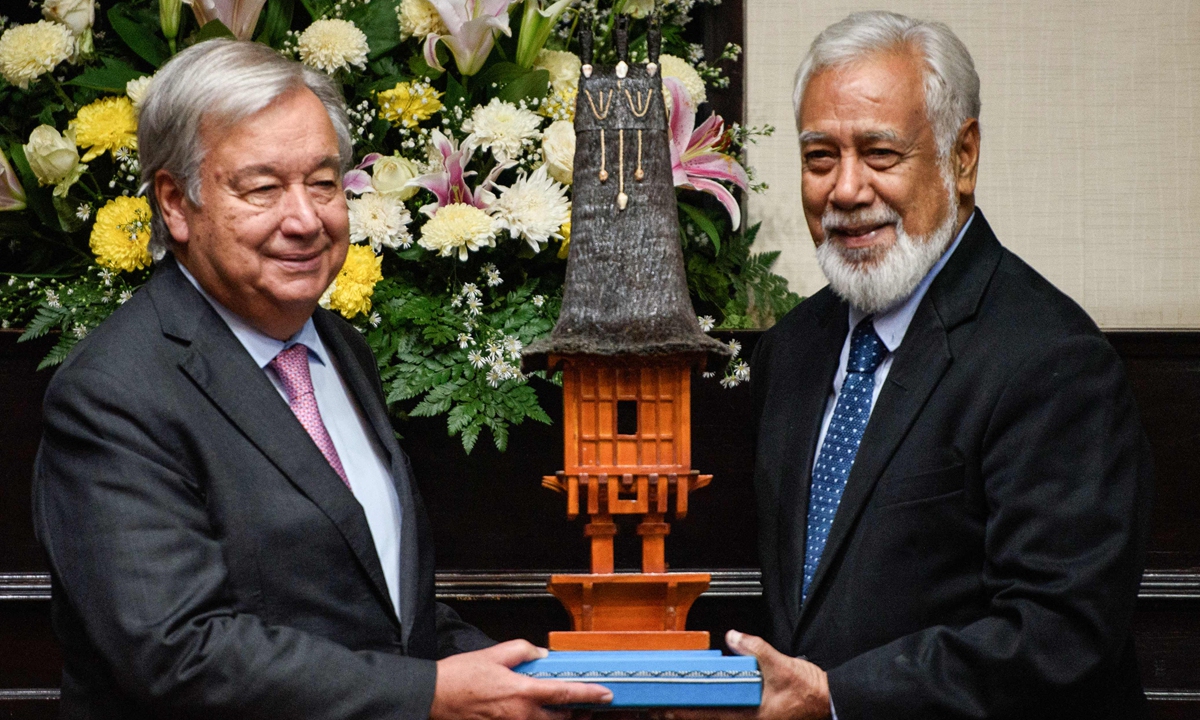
[710,12,1152,720]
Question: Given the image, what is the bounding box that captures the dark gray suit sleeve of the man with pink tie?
[34,366,437,720]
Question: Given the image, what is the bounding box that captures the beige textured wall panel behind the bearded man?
[745,0,1200,329]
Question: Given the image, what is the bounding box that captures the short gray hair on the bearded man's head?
[792,11,979,161]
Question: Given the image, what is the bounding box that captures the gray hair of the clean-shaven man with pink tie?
[138,38,354,258]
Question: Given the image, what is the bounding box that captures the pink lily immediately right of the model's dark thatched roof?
[662,78,749,230]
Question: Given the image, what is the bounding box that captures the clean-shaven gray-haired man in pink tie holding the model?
[34,40,611,720]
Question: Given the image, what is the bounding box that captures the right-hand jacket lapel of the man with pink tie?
[313,310,419,647]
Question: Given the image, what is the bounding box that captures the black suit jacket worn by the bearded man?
[751,214,1152,720]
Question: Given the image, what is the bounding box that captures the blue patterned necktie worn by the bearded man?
[800,317,888,602]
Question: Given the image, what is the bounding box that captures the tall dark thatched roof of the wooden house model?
[522,16,730,370]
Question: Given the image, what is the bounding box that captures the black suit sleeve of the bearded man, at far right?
[829,336,1152,720]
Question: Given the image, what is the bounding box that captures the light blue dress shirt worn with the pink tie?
[179,264,401,617]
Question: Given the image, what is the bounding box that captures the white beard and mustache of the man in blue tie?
[817,186,959,314]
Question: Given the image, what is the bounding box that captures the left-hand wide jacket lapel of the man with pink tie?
[148,259,395,619]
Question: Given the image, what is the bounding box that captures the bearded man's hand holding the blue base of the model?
[725,630,830,720]
